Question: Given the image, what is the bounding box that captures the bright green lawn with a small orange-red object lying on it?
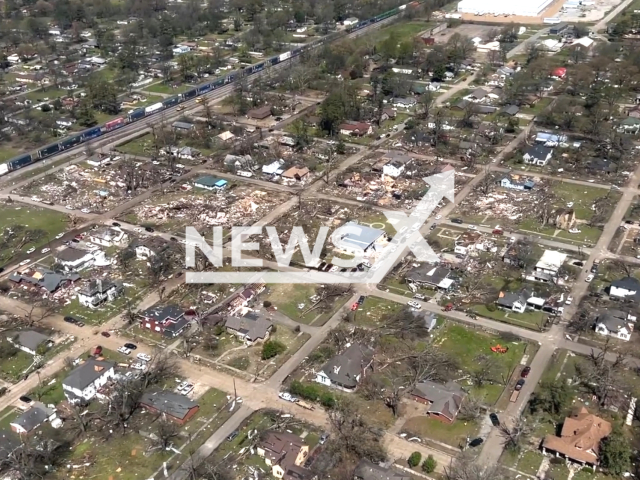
[434,323,528,405]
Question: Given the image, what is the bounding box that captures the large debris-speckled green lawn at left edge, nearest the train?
[0,202,69,262]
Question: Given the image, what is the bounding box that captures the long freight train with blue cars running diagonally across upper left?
[0,1,422,175]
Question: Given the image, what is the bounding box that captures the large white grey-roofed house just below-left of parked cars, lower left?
[62,358,116,403]
